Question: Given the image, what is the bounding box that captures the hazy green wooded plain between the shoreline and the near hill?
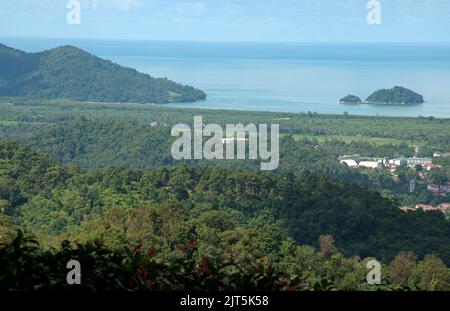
[0,103,450,206]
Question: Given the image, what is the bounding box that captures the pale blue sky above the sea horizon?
[0,0,450,42]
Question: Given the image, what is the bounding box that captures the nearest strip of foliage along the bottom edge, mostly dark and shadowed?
[0,232,450,293]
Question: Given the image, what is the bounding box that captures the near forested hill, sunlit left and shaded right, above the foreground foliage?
[0,141,450,265]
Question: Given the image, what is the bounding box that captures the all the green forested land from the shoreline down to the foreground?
[0,102,450,290]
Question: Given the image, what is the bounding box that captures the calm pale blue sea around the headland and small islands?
[0,38,450,118]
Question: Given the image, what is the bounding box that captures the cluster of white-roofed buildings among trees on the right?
[339,154,439,171]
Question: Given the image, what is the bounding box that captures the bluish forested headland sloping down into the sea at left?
[0,44,206,104]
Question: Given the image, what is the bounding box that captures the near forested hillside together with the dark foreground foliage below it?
[0,142,450,290]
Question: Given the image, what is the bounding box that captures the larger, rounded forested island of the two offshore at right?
[364,86,425,105]
